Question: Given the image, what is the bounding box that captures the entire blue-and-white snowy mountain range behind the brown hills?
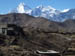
[10,3,75,22]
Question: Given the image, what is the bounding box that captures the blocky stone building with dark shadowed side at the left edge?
[0,23,20,35]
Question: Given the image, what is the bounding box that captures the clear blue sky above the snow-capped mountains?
[0,0,75,13]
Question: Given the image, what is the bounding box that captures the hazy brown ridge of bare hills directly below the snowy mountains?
[0,13,75,32]
